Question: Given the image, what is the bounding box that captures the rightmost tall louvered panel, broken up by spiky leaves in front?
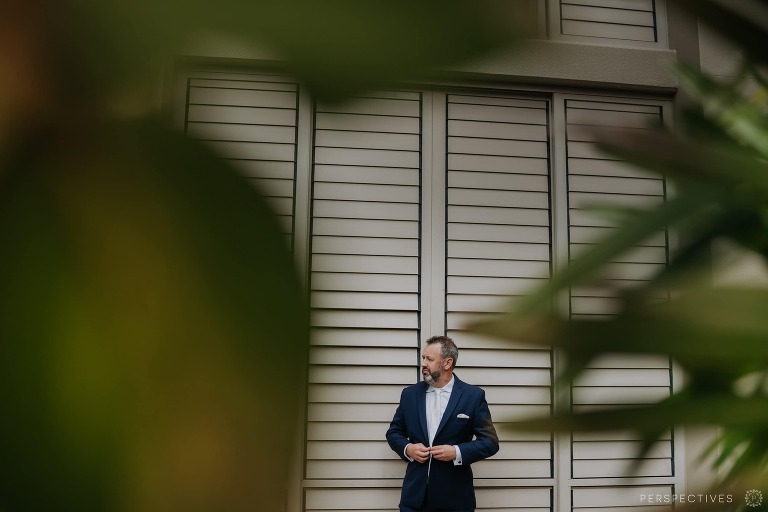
[566,100,673,480]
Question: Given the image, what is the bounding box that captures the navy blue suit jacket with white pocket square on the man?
[387,375,499,510]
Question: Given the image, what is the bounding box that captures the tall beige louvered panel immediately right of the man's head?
[446,95,552,482]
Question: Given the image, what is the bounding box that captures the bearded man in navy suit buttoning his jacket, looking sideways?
[387,336,499,512]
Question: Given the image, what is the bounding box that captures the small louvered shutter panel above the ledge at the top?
[560,0,658,42]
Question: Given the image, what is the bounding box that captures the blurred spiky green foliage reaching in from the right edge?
[475,0,768,500]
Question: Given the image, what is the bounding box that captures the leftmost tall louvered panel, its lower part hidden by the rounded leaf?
[185,73,298,241]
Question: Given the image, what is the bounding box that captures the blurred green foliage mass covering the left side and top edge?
[0,0,509,512]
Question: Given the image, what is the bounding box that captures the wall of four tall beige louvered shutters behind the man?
[177,69,679,512]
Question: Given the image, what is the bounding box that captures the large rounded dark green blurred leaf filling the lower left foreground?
[0,120,307,512]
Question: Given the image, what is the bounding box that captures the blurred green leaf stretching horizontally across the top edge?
[57,0,514,99]
